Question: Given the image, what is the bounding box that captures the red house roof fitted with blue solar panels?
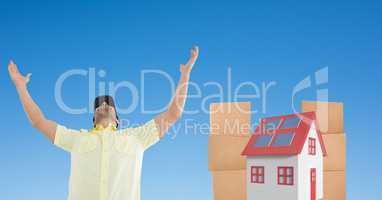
[242,112,326,156]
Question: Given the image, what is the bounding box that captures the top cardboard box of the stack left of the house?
[210,102,252,136]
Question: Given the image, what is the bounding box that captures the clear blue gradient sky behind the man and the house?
[0,0,382,200]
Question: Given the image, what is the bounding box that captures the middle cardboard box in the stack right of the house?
[322,134,346,171]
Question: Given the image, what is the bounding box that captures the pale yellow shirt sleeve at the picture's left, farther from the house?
[54,125,83,152]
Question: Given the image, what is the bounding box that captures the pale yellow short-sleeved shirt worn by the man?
[54,120,159,200]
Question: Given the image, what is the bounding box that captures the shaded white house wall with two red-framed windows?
[247,156,299,200]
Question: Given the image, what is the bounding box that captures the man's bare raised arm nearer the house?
[155,47,199,137]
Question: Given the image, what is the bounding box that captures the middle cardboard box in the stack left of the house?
[208,135,251,171]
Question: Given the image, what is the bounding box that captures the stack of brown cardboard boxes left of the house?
[208,102,251,200]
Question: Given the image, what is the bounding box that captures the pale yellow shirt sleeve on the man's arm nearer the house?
[123,120,159,150]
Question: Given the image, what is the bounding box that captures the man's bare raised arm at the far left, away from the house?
[8,61,57,143]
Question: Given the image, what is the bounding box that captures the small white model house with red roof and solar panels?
[242,112,326,200]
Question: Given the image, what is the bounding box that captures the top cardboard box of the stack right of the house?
[301,101,344,134]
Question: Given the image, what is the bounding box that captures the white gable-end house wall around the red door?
[298,124,324,200]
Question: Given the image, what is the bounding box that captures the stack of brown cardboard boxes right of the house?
[302,101,346,200]
